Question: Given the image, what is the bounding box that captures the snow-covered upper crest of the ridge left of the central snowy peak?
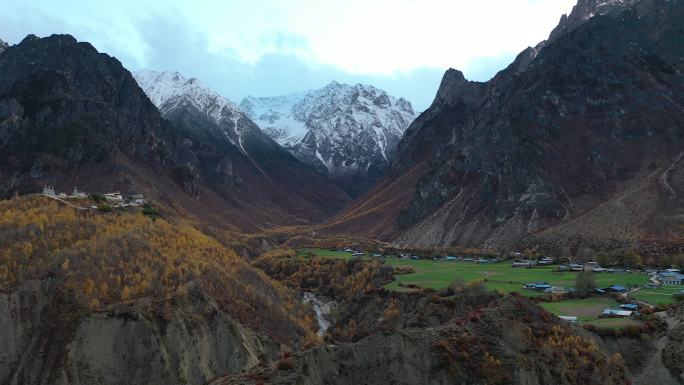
[133,70,259,154]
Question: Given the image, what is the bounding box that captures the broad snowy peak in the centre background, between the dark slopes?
[240,81,416,195]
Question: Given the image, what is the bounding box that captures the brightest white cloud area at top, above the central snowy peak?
[166,0,575,74]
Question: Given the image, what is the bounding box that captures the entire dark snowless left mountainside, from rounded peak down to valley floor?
[0,35,348,229]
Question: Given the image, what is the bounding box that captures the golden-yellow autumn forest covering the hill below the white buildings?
[0,197,315,342]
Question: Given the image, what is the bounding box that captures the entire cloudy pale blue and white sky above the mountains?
[0,0,576,110]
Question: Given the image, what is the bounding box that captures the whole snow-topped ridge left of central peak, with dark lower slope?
[134,70,350,219]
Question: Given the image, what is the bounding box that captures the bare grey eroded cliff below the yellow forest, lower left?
[0,280,279,385]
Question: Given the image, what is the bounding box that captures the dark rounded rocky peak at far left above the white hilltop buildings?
[0,35,187,192]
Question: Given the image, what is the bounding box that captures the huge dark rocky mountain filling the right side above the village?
[334,1,684,247]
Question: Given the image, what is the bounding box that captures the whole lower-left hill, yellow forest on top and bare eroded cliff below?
[0,197,314,384]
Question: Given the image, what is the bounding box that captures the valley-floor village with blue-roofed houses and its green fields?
[300,248,684,327]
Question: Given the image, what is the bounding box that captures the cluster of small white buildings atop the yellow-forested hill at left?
[37,186,147,210]
